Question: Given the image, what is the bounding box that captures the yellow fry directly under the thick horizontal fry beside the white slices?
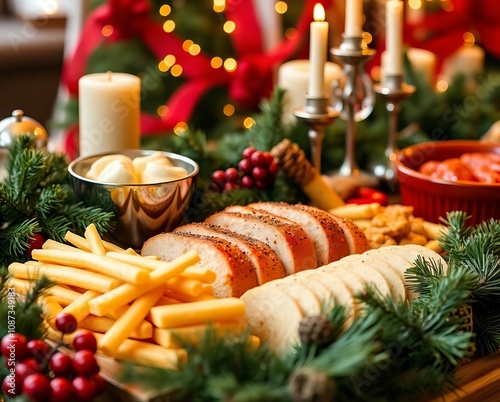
[153,320,245,348]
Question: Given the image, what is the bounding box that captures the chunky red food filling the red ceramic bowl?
[418,152,500,184]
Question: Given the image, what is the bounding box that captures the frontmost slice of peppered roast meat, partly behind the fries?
[141,233,258,297]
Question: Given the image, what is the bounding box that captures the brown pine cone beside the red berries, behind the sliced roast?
[270,138,318,186]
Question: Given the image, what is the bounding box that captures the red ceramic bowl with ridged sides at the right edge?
[395,140,500,224]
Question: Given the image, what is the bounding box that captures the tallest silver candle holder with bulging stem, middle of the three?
[330,35,376,176]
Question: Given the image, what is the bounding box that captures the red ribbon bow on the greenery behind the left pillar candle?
[62,0,333,135]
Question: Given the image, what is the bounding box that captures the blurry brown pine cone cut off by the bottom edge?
[288,367,336,402]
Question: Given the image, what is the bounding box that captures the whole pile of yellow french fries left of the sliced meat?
[8,224,254,368]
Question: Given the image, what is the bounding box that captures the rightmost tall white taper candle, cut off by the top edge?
[384,0,403,76]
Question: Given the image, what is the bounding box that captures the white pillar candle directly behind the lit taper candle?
[277,59,342,122]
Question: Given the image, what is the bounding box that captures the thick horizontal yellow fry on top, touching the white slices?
[151,297,245,328]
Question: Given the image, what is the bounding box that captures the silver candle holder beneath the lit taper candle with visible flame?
[293,95,339,173]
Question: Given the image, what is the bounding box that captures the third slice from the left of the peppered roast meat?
[205,211,318,275]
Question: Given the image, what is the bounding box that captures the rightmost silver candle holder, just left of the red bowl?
[372,74,415,192]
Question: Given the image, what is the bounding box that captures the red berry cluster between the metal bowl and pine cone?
[211,147,279,193]
